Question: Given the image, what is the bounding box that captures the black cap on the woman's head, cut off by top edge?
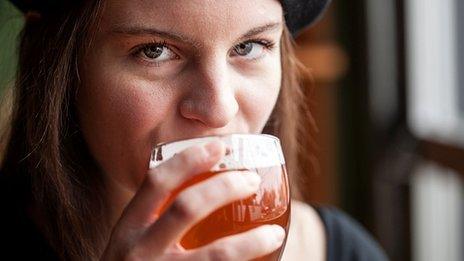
[10,0,331,36]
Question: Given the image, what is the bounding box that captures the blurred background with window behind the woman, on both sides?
[0,0,464,261]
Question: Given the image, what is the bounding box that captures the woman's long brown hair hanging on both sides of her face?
[0,0,313,260]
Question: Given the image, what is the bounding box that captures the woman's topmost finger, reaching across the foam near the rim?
[119,140,225,226]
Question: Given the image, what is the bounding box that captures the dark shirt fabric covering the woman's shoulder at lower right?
[316,204,388,261]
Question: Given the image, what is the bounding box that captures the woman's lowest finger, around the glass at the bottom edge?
[190,225,285,260]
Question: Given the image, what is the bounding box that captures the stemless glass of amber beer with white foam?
[150,134,290,260]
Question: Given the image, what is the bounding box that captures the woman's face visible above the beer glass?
[77,0,283,189]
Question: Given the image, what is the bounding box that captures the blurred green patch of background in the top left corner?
[0,0,24,97]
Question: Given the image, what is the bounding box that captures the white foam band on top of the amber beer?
[150,134,285,171]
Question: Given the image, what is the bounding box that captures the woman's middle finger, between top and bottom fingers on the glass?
[140,171,261,249]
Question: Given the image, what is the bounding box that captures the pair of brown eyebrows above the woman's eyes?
[110,22,282,46]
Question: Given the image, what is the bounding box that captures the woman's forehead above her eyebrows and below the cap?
[102,0,283,41]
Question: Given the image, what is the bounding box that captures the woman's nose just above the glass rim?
[179,59,239,128]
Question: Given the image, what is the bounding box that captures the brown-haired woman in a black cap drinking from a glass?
[2,0,384,260]
